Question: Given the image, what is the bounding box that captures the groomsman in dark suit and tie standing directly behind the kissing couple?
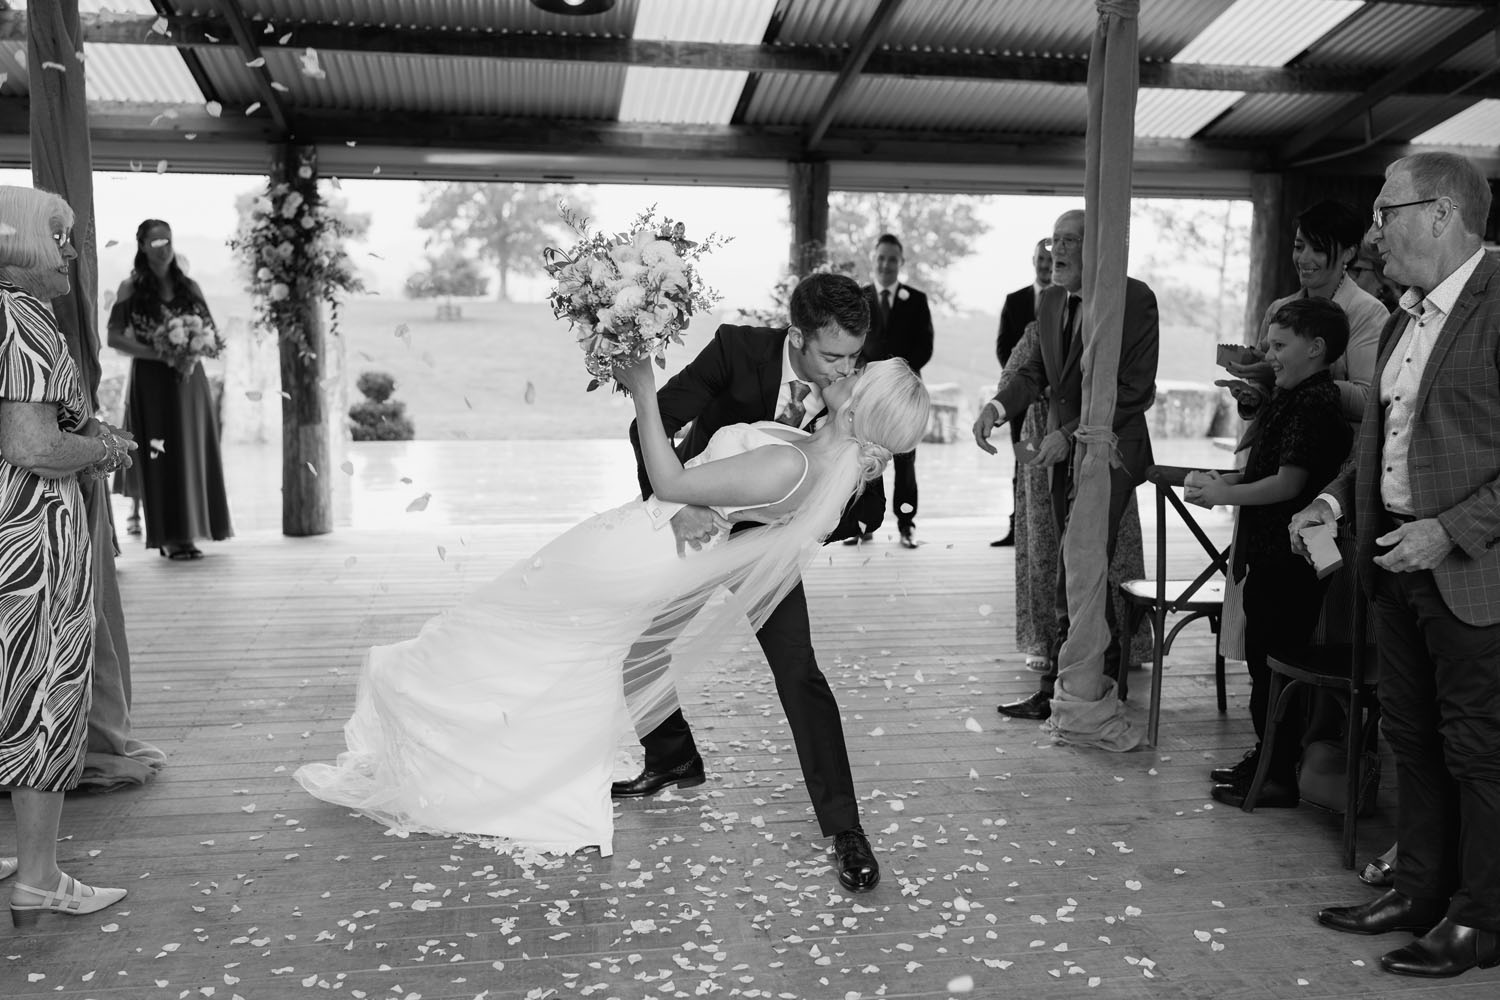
[845,232,933,549]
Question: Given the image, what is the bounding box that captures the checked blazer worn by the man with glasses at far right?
[1325,253,1500,625]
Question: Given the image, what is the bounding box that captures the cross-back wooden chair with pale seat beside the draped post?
[1121,465,1229,747]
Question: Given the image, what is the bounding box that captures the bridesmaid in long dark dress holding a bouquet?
[110,219,234,559]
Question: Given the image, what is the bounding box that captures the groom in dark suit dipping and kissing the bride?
[611,274,881,892]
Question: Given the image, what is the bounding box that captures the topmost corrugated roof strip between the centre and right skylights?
[777,0,1233,58]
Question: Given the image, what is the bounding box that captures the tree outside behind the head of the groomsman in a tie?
[827,190,990,306]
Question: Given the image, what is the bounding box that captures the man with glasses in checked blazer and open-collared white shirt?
[1289,153,1500,978]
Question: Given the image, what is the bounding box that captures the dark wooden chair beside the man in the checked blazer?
[1241,575,1380,868]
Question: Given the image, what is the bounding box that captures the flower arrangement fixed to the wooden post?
[228,146,365,355]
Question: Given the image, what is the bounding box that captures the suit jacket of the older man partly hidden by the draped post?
[995,277,1161,486]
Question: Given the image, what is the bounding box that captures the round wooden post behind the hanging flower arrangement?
[272,144,333,537]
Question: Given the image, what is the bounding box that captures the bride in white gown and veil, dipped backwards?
[296,360,929,855]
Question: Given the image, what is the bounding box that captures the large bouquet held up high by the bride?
[543,205,729,390]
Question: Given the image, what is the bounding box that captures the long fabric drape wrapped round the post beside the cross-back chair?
[1047,0,1140,750]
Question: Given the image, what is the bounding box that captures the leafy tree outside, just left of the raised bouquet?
[417,181,593,301]
